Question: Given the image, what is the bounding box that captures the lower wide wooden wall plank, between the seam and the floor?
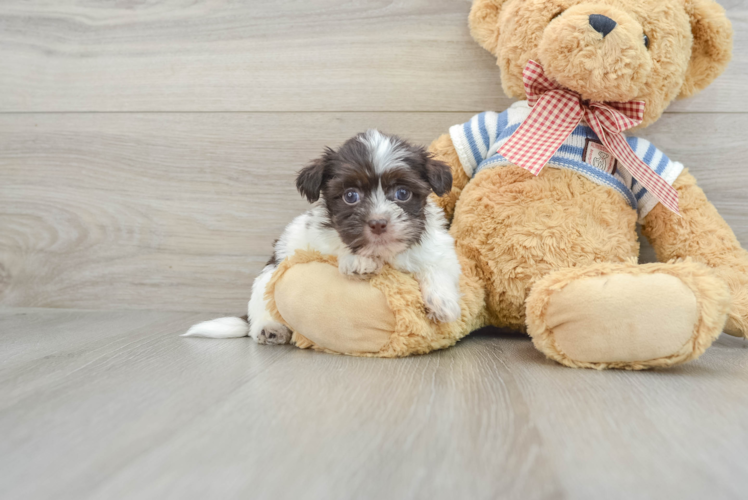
[0,113,748,313]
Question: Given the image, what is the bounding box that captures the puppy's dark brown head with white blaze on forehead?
[296,130,452,257]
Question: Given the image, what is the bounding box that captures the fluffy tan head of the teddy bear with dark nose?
[470,0,732,125]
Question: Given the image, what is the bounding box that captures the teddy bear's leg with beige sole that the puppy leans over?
[265,251,485,357]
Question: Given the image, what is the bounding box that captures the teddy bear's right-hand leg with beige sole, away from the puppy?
[527,259,730,370]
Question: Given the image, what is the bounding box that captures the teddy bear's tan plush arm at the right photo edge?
[642,170,748,337]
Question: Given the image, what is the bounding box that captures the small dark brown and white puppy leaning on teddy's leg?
[184,130,460,344]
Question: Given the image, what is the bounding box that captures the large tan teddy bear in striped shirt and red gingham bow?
[266,0,748,370]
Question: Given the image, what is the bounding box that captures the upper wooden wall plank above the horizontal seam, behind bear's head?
[0,0,748,112]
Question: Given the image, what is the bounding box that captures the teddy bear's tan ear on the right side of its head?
[679,0,732,97]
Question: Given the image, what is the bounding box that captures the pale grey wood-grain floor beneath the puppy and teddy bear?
[0,309,748,500]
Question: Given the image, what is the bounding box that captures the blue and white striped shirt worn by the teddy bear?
[449,101,683,221]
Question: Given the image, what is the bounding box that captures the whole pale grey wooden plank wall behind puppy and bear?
[0,0,748,312]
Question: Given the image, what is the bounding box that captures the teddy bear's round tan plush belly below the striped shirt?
[452,167,639,330]
